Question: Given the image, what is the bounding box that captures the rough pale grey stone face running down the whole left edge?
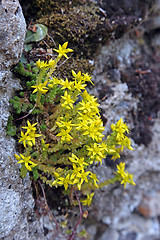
[0,0,44,240]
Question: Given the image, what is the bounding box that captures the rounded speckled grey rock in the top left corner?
[0,0,26,70]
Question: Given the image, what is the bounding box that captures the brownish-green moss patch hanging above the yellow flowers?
[19,0,115,77]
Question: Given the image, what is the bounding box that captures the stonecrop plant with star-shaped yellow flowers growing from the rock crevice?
[11,42,135,206]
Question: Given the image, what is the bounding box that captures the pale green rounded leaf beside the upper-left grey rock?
[25,24,48,43]
